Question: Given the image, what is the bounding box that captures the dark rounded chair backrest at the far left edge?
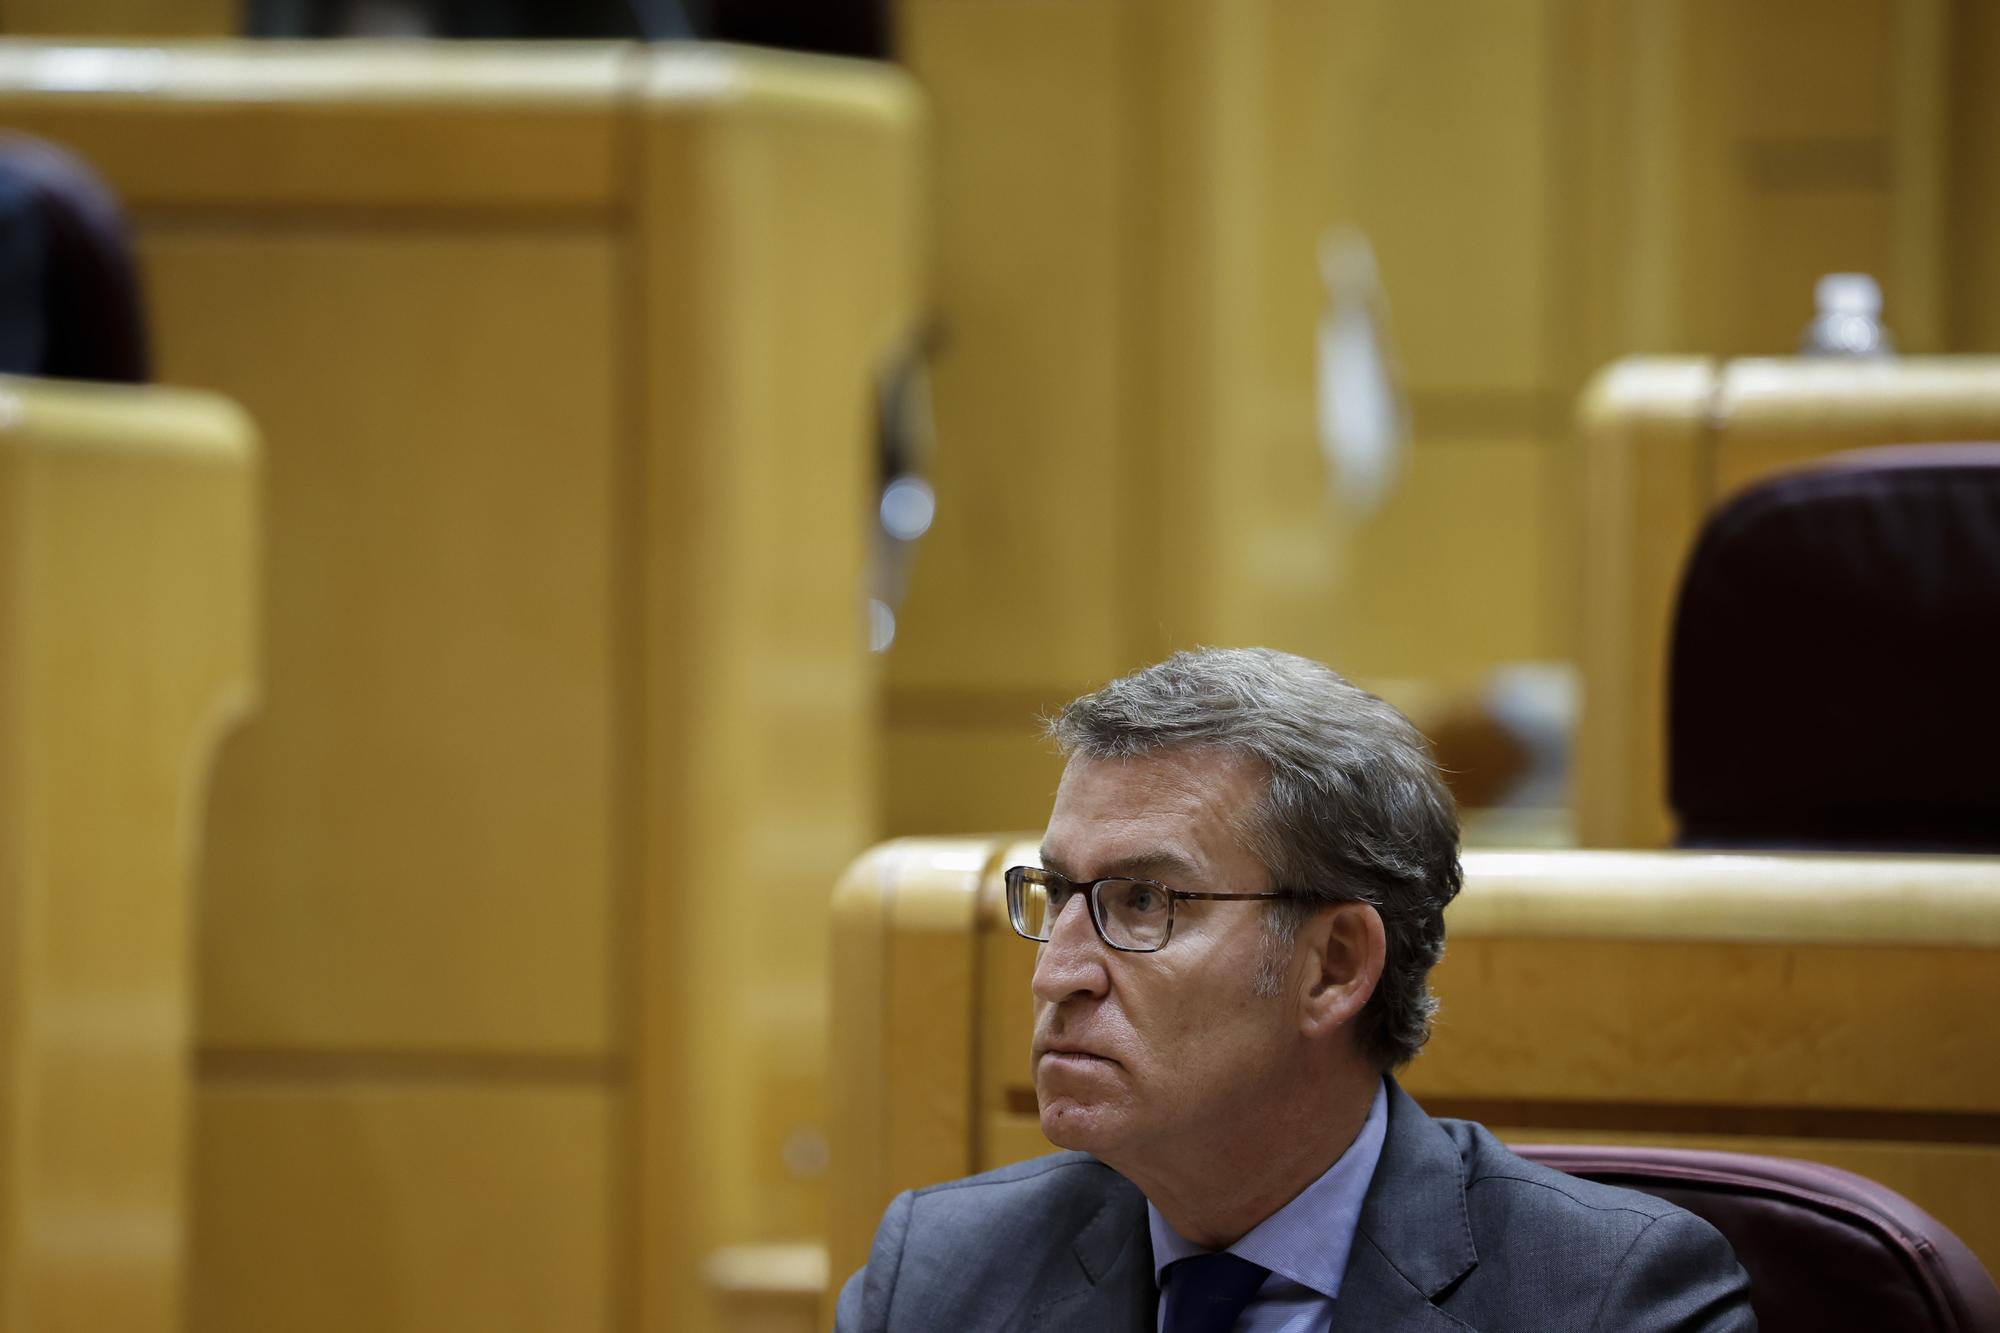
[0,134,148,384]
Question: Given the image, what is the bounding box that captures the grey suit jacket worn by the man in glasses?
[836,1081,1756,1333]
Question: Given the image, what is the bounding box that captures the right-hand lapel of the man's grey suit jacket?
[1332,1079,1478,1333]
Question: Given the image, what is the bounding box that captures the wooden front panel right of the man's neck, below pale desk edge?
[1406,939,2000,1111]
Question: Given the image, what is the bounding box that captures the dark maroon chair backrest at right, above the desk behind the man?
[1668,444,2000,851]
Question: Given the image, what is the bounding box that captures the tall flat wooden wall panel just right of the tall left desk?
[888,0,1130,695]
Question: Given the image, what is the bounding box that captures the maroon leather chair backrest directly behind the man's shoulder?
[1516,1143,2000,1333]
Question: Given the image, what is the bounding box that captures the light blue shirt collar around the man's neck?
[1146,1083,1388,1297]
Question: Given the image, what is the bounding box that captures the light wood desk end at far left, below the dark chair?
[0,376,258,1333]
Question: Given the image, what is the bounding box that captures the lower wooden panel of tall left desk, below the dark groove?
[190,1077,618,1333]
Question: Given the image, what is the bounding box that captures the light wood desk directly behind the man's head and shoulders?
[828,837,2000,1285]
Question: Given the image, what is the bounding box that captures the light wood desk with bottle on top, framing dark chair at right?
[1576,356,2000,847]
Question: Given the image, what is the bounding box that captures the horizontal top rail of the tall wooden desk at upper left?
[0,42,632,216]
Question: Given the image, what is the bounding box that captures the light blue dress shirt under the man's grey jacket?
[1146,1083,1388,1333]
